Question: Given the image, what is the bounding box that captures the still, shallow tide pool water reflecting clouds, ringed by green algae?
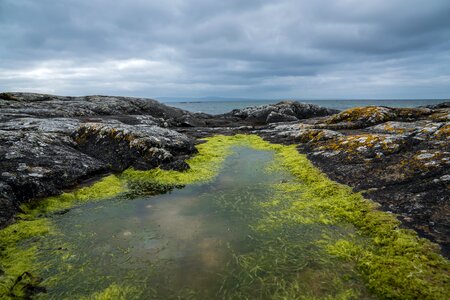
[34,147,370,299]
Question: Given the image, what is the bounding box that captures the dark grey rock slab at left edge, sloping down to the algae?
[0,129,107,216]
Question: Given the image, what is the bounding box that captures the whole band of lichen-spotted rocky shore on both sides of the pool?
[0,93,450,257]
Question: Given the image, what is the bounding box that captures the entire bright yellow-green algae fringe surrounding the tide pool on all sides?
[0,135,450,299]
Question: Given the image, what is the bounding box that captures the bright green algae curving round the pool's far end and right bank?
[121,135,450,299]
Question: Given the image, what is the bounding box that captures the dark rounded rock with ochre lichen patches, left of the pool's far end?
[72,123,195,171]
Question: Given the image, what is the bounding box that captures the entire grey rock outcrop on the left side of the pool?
[0,93,200,228]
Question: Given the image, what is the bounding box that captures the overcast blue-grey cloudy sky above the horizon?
[0,0,450,99]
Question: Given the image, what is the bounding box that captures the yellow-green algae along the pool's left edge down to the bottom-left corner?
[0,175,125,298]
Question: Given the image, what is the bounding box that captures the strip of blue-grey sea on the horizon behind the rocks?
[165,99,445,115]
